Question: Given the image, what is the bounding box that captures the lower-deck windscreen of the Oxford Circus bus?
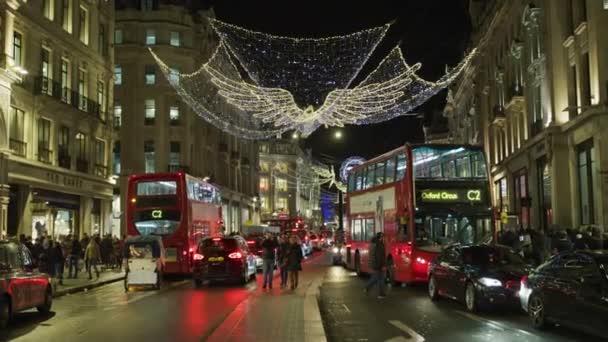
[415,215,492,247]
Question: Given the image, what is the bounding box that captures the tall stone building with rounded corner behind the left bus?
[113,0,258,232]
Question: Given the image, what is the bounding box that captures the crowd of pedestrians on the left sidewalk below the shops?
[19,233,124,286]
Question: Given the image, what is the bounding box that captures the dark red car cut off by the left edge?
[0,241,53,329]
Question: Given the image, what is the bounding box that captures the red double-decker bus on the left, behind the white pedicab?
[126,172,223,274]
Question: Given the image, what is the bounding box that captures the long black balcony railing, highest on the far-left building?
[34,76,103,121]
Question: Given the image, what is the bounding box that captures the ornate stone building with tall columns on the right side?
[444,0,608,231]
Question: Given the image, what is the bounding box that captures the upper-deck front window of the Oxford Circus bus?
[412,146,488,181]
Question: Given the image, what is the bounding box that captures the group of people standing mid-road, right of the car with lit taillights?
[260,233,304,290]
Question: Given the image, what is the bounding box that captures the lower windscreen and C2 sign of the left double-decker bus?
[133,209,180,236]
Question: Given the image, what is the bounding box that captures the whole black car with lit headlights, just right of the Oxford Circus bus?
[428,245,530,311]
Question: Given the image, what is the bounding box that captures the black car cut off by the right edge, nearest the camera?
[521,251,608,337]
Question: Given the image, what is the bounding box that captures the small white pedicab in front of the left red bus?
[123,235,165,291]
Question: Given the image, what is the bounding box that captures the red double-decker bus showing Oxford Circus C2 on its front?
[342,144,494,283]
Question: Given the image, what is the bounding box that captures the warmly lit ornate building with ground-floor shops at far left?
[0,0,114,237]
